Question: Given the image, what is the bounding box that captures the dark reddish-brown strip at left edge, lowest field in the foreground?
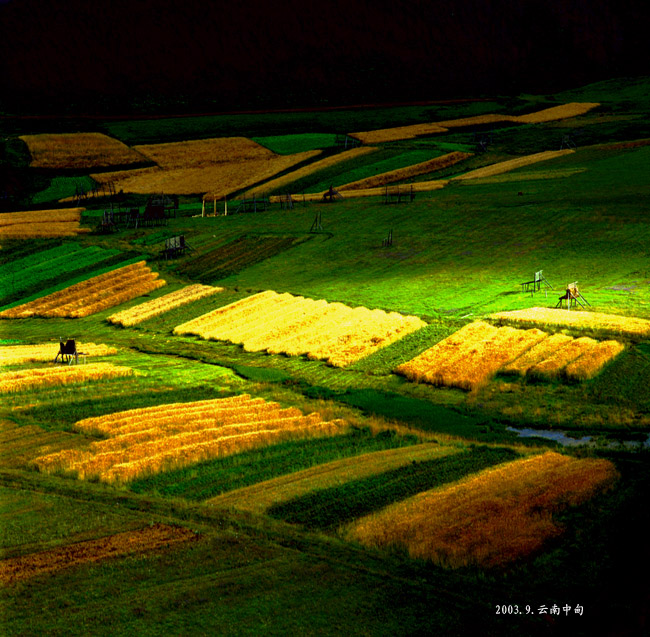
[0,524,198,584]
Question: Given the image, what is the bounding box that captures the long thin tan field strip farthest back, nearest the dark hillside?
[350,102,600,144]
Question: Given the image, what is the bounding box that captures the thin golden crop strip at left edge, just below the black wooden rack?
[0,363,133,394]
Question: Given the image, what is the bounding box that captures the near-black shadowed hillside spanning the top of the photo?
[0,0,647,113]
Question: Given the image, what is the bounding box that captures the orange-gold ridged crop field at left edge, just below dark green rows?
[0,261,166,318]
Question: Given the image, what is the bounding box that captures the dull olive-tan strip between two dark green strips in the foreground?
[206,443,460,513]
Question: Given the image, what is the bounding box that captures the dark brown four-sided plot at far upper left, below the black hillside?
[20,133,147,169]
